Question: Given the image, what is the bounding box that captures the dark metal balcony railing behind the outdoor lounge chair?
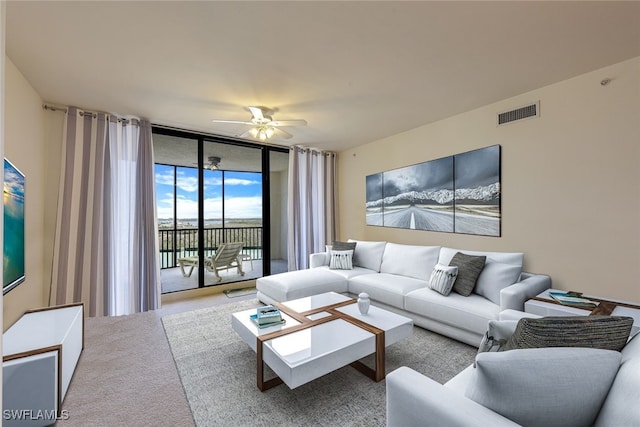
[159,227,262,268]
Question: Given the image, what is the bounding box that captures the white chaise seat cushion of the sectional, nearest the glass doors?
[256,267,353,302]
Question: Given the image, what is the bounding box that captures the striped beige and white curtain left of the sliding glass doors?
[49,107,160,316]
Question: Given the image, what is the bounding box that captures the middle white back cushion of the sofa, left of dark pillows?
[380,243,440,281]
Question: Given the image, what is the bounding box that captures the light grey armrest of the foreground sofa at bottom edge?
[386,366,518,427]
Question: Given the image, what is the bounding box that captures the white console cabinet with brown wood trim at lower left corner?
[2,303,84,426]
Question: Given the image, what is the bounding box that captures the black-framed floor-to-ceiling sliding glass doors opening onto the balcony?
[153,128,288,293]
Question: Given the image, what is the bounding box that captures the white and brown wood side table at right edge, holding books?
[524,289,640,335]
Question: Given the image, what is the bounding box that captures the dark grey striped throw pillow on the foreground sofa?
[502,316,633,351]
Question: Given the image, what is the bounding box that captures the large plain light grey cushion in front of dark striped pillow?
[465,348,622,427]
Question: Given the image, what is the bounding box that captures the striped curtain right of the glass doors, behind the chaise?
[288,147,336,271]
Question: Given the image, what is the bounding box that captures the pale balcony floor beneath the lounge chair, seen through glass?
[160,259,287,294]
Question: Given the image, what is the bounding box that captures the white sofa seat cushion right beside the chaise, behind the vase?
[349,273,428,308]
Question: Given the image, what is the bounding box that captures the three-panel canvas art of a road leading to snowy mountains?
[366,145,501,236]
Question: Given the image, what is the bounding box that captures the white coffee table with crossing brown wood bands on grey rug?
[231,292,413,391]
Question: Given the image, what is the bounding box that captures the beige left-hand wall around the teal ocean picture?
[3,58,49,330]
